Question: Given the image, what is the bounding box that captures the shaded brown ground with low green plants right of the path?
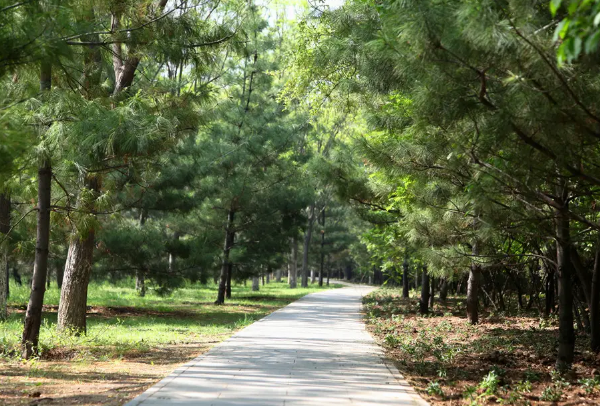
[363,289,600,406]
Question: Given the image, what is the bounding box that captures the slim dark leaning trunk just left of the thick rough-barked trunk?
[22,159,52,359]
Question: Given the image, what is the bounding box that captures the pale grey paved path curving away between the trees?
[126,286,427,406]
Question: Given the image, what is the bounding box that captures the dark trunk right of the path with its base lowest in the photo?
[556,203,575,371]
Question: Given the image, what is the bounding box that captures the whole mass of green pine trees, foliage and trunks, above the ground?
[0,0,600,382]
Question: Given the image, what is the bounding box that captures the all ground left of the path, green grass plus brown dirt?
[0,281,341,405]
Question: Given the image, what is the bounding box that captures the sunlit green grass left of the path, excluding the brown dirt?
[0,281,341,359]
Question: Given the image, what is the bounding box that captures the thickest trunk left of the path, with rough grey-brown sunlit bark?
[58,176,100,334]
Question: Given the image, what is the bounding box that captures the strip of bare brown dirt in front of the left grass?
[0,337,226,406]
